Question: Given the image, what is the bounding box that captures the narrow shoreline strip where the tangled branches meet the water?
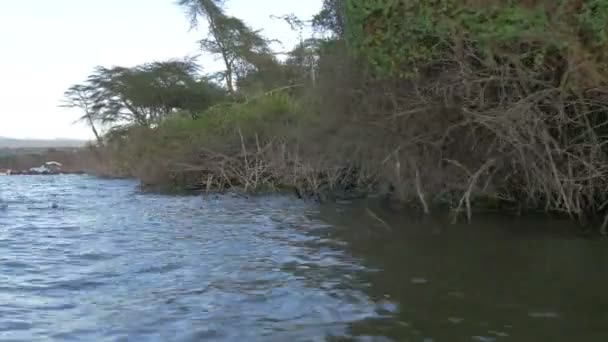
[0,171,606,239]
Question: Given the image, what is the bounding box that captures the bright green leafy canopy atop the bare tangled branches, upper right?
[346,0,608,76]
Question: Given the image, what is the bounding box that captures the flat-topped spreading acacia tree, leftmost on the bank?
[65,59,224,134]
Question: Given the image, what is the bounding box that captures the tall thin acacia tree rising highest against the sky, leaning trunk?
[178,0,276,94]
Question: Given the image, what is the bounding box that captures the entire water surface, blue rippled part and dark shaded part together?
[0,176,608,342]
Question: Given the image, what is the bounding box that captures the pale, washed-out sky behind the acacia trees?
[0,0,322,139]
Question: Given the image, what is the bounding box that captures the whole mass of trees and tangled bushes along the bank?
[66,0,608,229]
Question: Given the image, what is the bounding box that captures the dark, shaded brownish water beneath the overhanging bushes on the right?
[320,200,608,341]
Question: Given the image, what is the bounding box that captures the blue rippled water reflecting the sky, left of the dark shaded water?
[0,177,390,341]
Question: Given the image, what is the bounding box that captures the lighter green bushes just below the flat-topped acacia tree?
[106,93,302,174]
